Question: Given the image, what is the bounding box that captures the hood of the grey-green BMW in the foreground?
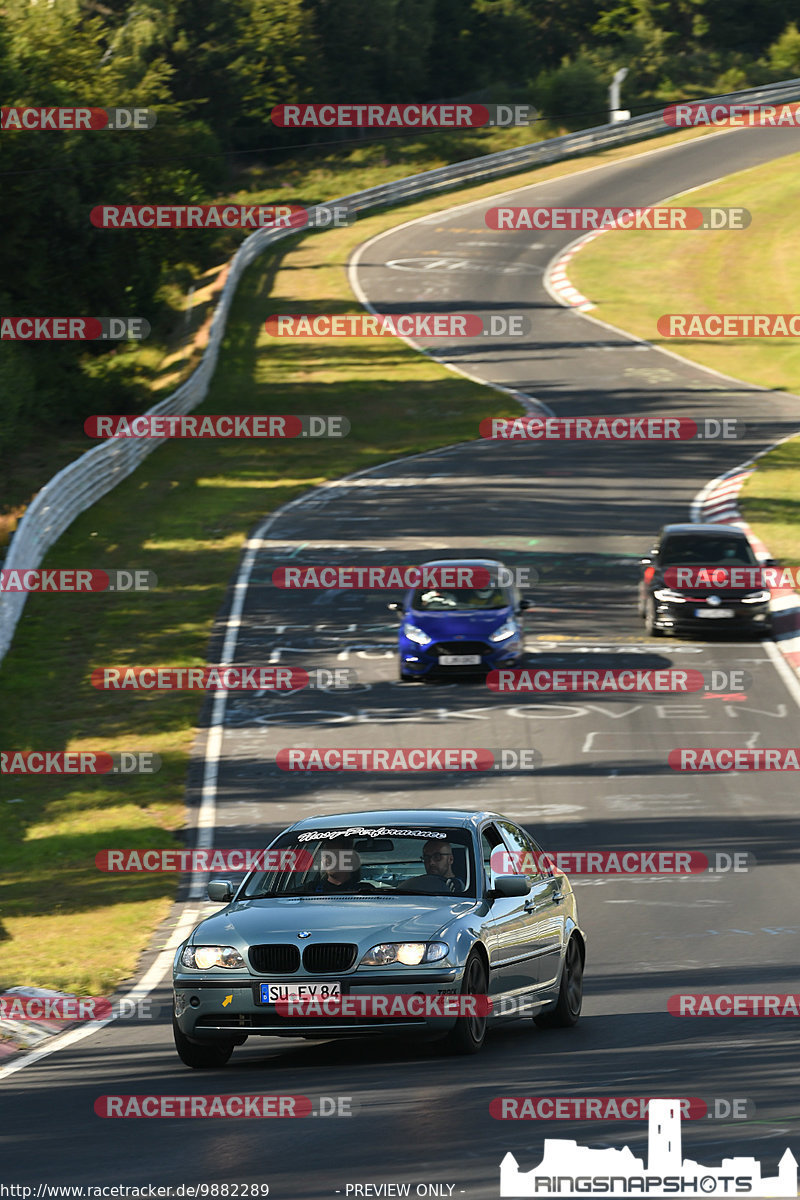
[191,895,476,952]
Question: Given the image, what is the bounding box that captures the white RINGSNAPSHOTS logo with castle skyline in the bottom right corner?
[500,1099,798,1200]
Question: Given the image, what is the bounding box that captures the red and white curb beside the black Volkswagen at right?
[692,458,800,672]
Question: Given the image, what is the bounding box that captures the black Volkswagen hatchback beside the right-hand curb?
[639,524,772,637]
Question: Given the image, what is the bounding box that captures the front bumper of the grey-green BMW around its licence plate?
[173,967,463,1042]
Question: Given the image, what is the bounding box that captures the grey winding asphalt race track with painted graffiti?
[0,130,800,1200]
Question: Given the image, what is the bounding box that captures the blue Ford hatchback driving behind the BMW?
[389,558,530,683]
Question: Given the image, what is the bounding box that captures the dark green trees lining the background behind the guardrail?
[0,0,800,460]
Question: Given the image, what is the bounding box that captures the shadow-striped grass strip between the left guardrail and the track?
[0,131,714,995]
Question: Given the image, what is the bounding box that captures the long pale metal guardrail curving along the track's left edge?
[0,78,800,662]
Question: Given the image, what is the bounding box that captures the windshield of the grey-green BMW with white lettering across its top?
[239,826,476,900]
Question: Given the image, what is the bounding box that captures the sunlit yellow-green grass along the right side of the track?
[569,155,800,563]
